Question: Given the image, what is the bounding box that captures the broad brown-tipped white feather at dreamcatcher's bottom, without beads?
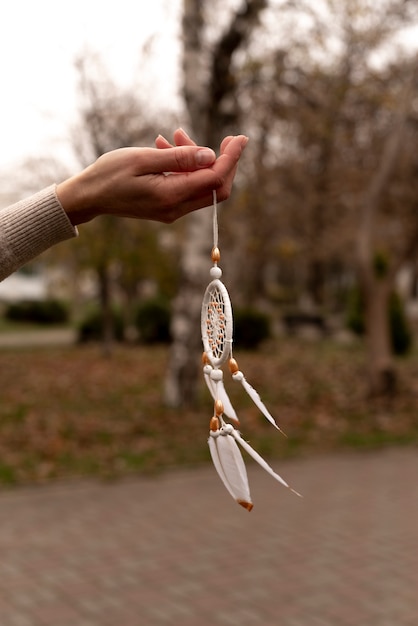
[215,434,251,504]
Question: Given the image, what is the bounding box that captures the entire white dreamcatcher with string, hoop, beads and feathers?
[201,191,300,511]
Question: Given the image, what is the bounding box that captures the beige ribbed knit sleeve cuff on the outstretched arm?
[0,185,78,280]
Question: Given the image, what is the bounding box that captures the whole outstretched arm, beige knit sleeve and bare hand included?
[0,130,248,280]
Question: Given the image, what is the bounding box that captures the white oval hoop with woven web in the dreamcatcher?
[201,278,233,367]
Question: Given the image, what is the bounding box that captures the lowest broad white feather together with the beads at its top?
[208,417,253,511]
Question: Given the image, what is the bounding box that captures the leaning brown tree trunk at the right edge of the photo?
[358,60,418,396]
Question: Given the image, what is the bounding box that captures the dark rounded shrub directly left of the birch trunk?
[135,297,171,345]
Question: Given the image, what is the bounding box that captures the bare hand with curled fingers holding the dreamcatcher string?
[57,129,248,225]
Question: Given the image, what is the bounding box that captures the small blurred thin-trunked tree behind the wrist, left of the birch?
[69,56,180,354]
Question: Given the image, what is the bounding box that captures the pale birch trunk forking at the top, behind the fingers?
[165,0,266,407]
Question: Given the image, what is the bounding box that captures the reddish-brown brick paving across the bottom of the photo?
[0,448,418,626]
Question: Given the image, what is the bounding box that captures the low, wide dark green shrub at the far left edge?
[5,299,69,324]
